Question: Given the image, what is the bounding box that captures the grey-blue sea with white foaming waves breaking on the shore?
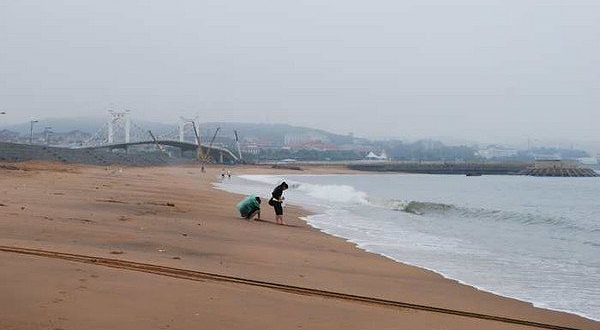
[215,173,600,320]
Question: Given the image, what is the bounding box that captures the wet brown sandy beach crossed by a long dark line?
[0,162,600,330]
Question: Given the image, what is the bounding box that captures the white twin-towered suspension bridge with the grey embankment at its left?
[0,111,241,166]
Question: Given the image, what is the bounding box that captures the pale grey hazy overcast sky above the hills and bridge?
[0,0,600,141]
